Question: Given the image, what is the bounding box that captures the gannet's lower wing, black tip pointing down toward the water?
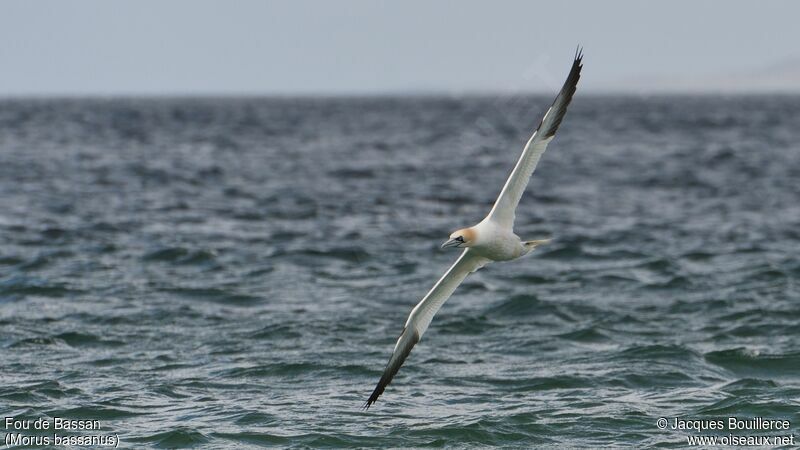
[364,249,489,408]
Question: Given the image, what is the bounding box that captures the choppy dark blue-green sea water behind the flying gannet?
[0,95,800,449]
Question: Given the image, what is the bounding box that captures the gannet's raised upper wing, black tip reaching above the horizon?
[482,50,583,229]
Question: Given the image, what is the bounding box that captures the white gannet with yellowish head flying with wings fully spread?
[364,49,583,408]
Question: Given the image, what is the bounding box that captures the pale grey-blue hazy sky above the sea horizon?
[0,0,800,96]
